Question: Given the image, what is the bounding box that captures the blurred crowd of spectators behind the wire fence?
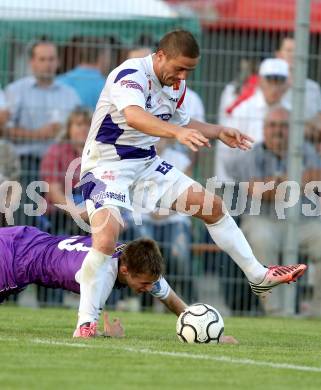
[0,35,321,316]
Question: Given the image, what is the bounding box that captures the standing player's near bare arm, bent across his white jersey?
[123,106,210,152]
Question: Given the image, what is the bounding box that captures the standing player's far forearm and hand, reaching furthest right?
[185,119,254,150]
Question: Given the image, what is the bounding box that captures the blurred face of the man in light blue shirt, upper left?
[30,43,58,80]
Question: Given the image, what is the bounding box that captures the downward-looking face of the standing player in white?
[154,50,199,87]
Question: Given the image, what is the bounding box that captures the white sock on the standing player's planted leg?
[77,248,111,327]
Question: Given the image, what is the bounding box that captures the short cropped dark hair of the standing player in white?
[157,30,200,58]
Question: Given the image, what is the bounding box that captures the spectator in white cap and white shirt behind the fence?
[215,58,289,181]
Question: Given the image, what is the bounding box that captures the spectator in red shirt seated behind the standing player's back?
[40,107,91,234]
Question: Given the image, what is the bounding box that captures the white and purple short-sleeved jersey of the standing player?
[82,55,190,176]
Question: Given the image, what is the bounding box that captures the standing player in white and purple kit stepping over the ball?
[75,30,306,337]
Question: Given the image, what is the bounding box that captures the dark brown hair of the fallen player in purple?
[120,238,164,278]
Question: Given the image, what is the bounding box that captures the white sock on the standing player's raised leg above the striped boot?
[206,214,266,283]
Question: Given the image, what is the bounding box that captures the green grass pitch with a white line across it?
[0,306,321,390]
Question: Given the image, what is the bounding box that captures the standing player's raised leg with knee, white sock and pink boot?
[172,184,307,296]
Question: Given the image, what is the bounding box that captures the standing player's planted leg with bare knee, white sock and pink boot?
[73,208,120,338]
